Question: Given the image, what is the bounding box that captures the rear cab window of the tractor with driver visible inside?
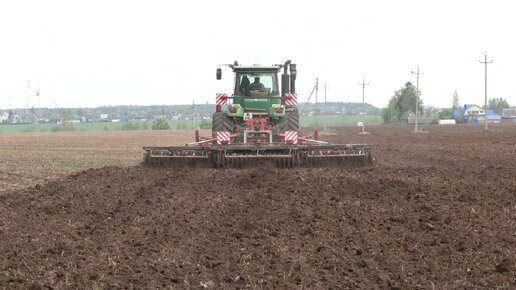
[235,73,278,97]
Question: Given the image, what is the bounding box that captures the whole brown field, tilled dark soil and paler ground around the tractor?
[0,125,516,289]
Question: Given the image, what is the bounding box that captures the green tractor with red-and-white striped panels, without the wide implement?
[212,61,299,144]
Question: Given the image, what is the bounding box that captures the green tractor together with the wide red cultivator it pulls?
[143,60,372,168]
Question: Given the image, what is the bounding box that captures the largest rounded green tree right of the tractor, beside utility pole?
[381,82,423,124]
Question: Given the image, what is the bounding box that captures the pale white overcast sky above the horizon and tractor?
[0,0,516,109]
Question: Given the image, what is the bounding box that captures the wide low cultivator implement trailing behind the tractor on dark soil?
[144,143,372,168]
